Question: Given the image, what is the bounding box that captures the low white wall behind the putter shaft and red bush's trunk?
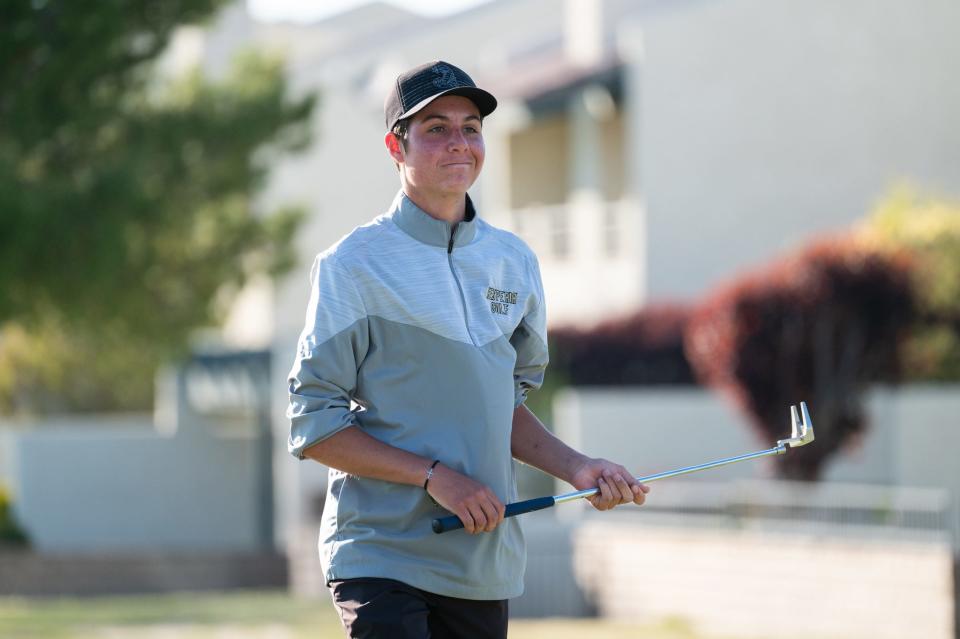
[554,385,960,508]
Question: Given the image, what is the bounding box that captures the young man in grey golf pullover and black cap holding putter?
[288,61,647,638]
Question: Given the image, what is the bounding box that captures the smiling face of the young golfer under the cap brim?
[403,96,484,195]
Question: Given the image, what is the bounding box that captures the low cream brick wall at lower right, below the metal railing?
[574,517,954,639]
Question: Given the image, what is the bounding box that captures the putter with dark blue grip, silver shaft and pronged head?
[432,402,813,534]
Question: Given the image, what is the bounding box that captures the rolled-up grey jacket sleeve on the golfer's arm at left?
[287,254,369,459]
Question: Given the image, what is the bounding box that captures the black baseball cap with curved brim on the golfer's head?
[383,60,497,131]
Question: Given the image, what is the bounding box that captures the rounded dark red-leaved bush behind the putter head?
[684,238,916,480]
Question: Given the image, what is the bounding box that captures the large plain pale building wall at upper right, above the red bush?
[621,0,960,298]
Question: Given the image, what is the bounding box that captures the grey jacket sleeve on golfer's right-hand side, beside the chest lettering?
[510,256,550,407]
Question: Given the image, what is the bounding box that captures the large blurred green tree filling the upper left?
[0,0,315,413]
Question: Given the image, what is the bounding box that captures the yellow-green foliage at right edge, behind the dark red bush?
[859,186,960,381]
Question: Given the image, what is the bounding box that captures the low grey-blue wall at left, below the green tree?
[0,370,263,554]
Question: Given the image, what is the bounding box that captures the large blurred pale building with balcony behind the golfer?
[176,0,960,560]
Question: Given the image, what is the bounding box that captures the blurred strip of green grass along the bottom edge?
[0,591,752,639]
